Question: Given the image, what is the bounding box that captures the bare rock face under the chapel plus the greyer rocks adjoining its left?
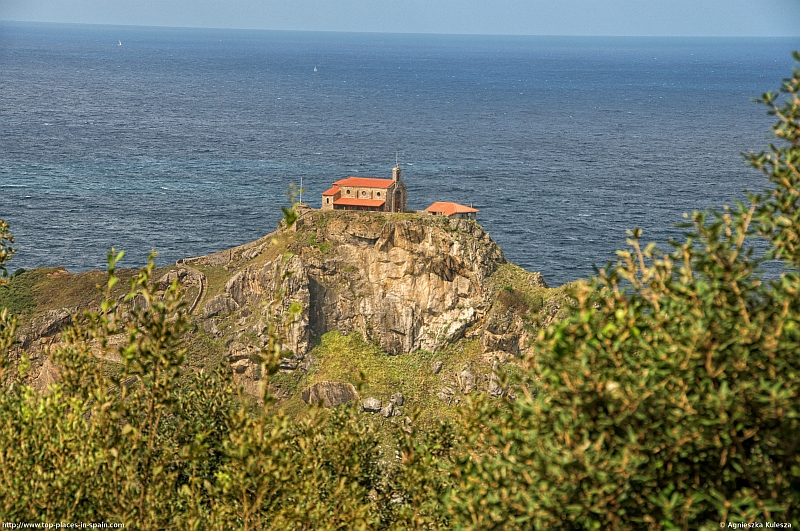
[196,212,504,356]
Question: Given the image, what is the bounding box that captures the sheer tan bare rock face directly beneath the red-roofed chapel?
[308,217,504,354]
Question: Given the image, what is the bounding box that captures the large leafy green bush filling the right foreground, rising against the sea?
[432,55,800,529]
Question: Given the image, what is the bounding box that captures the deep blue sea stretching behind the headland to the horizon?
[0,22,800,285]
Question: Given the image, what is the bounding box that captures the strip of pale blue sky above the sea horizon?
[0,0,800,37]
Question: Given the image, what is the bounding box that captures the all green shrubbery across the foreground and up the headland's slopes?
[0,54,800,530]
